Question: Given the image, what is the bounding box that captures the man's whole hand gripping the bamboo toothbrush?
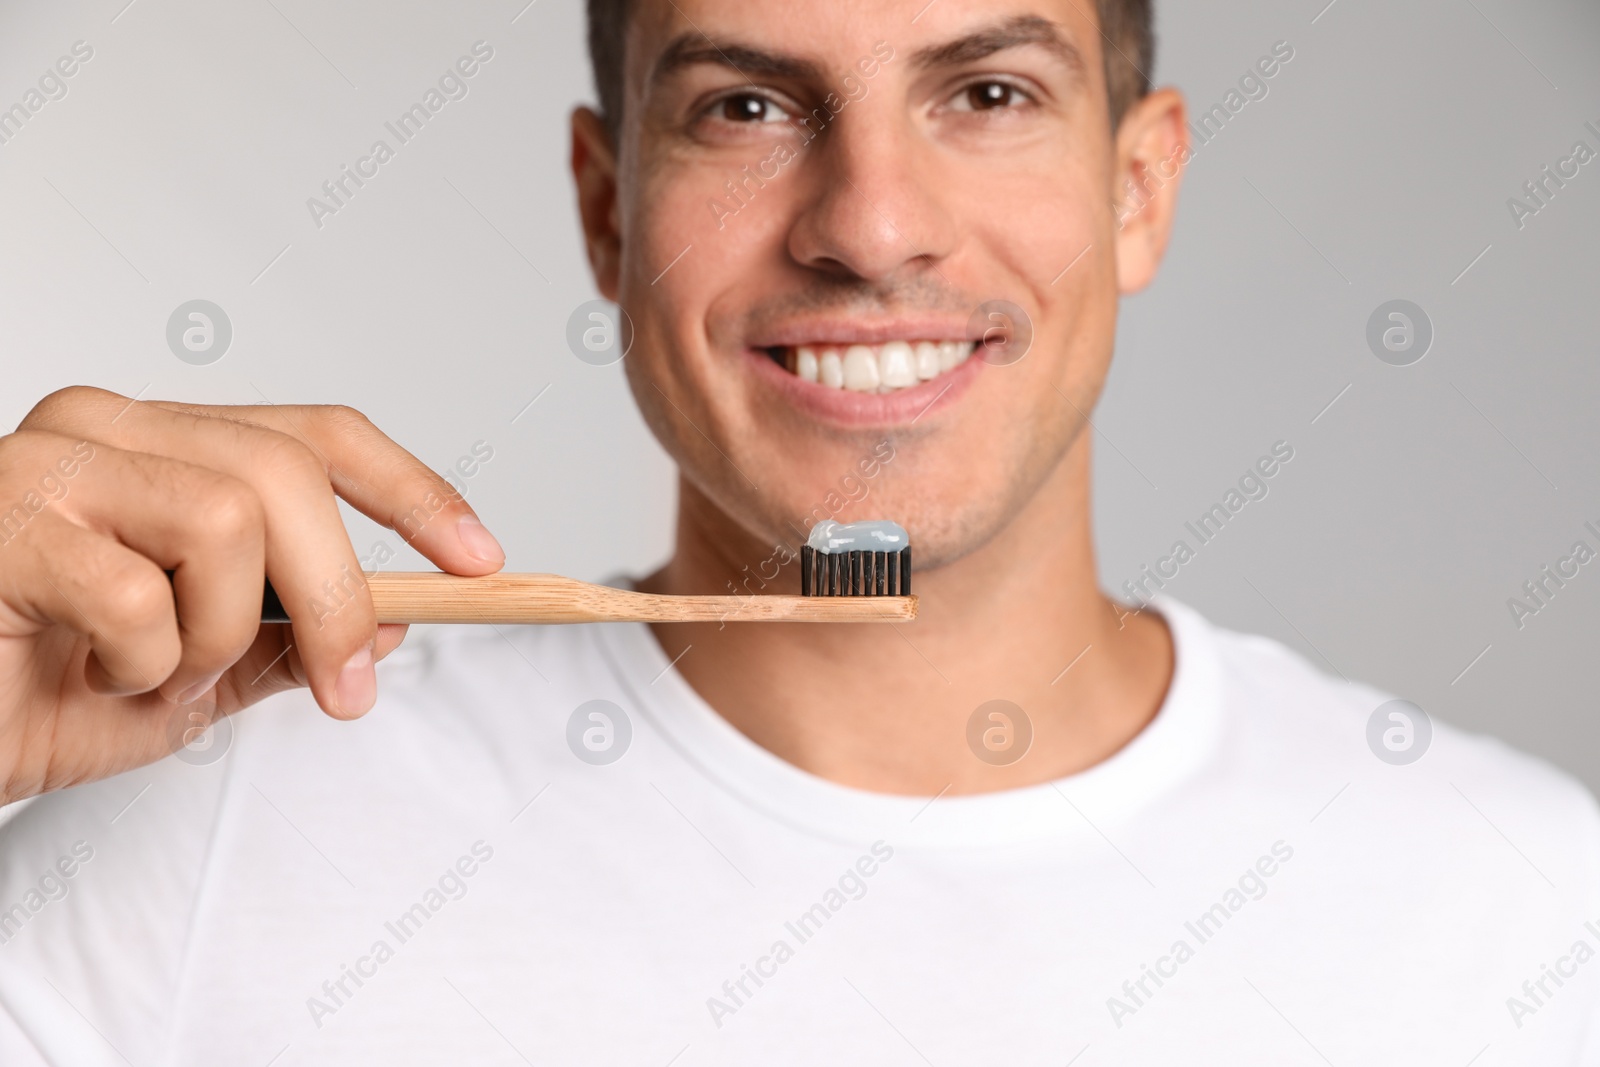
[0,387,504,803]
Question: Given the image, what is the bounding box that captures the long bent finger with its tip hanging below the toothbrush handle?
[29,390,378,718]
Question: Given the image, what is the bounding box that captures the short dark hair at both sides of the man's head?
[587,0,1155,139]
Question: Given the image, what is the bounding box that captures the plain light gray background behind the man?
[0,0,1600,787]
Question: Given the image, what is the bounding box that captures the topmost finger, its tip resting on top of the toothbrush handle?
[154,402,506,576]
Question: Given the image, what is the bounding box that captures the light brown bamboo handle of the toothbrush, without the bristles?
[261,571,917,624]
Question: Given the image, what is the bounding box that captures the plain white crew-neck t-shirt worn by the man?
[0,601,1600,1067]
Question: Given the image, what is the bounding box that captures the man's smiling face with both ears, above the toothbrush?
[574,0,1182,569]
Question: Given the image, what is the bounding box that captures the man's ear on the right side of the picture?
[1112,90,1189,293]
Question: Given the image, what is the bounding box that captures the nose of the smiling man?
[789,99,957,282]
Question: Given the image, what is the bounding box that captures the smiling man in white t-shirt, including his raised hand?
[0,0,1600,1065]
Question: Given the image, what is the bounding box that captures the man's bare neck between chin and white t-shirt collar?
[642,437,1173,795]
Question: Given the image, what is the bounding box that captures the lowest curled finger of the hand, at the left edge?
[0,512,182,694]
